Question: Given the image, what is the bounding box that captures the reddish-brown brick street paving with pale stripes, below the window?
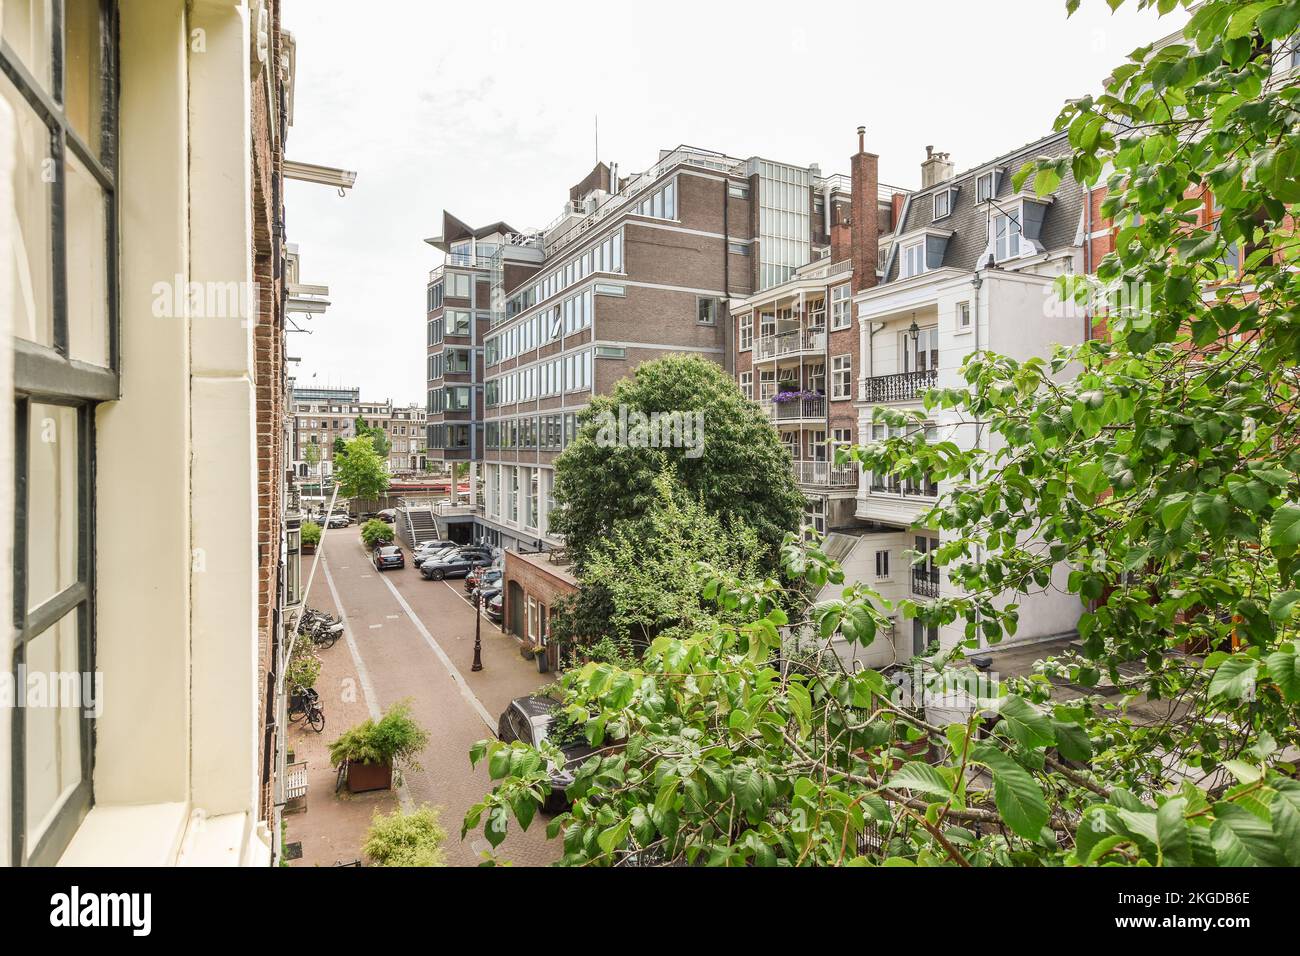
[286,528,562,866]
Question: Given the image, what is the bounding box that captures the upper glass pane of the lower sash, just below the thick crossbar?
[27,402,81,610]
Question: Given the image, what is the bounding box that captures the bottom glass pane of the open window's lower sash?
[22,610,85,848]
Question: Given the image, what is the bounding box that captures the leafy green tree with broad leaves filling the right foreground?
[465,0,1300,866]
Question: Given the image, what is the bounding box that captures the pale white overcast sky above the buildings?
[283,0,1186,405]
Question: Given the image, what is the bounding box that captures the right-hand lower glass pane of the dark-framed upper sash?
[65,152,108,368]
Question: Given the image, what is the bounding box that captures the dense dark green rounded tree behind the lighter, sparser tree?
[551,356,805,568]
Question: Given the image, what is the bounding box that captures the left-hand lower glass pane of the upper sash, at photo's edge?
[0,78,55,345]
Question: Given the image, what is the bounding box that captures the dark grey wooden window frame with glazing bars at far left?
[0,0,121,866]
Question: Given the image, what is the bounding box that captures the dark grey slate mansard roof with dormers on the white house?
[885,131,1083,282]
